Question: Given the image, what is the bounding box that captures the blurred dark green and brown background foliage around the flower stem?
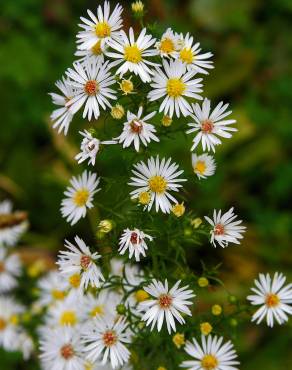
[0,0,292,370]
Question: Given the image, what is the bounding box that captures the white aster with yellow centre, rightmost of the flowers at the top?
[178,33,214,75]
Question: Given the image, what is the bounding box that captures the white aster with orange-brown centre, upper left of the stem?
[66,58,116,121]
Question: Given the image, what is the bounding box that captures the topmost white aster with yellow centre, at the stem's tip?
[77,1,123,50]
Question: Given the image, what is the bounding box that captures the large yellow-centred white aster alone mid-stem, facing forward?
[129,156,186,213]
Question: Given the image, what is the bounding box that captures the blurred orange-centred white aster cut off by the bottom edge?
[40,326,84,370]
